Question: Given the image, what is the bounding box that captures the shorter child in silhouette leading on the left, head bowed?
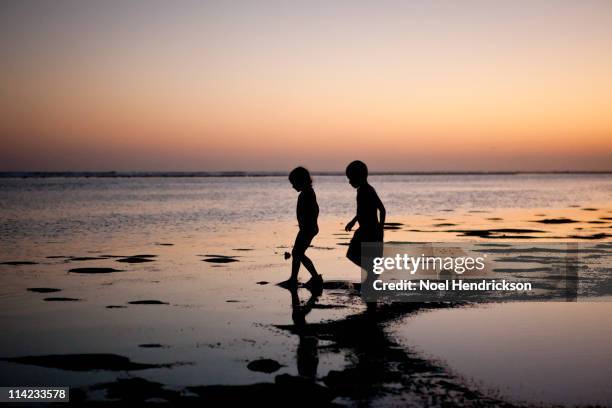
[281,167,323,287]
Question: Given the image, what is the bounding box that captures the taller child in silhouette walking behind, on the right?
[345,160,386,266]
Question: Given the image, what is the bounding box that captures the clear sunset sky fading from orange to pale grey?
[0,0,612,171]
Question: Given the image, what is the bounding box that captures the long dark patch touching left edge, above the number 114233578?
[0,353,172,371]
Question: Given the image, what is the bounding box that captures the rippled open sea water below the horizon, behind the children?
[0,174,612,245]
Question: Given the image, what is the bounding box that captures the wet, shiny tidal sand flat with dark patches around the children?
[0,205,612,406]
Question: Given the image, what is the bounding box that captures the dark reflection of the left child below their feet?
[289,287,321,380]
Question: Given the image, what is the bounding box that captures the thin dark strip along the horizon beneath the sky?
[0,170,612,178]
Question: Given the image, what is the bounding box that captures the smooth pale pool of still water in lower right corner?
[394,299,612,406]
